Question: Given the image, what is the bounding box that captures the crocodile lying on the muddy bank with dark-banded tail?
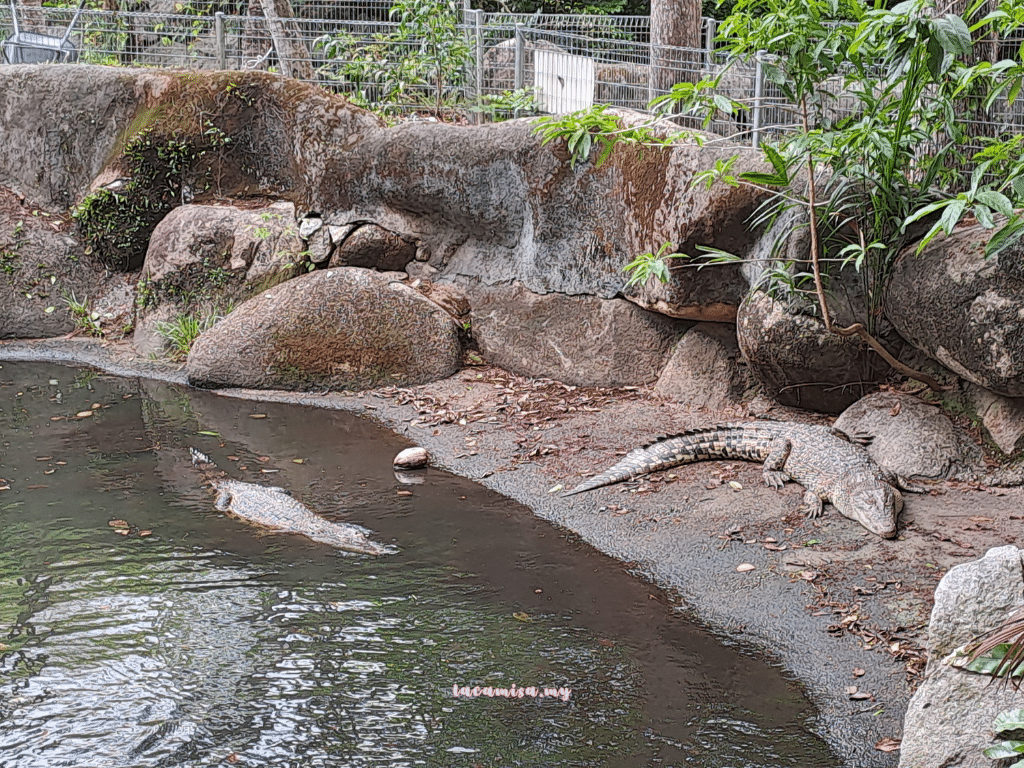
[563,421,916,539]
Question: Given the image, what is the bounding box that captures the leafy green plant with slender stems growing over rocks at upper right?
[536,0,1024,389]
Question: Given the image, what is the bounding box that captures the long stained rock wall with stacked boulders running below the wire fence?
[0,66,1024,442]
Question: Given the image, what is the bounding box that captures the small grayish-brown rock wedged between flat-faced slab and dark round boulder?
[654,323,750,411]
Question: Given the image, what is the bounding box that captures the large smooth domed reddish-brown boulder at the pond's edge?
[185,267,462,390]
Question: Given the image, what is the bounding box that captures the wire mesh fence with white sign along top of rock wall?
[6,0,1024,145]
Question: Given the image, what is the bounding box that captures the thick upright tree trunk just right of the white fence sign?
[650,0,702,95]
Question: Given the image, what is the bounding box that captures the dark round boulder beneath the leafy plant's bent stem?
[736,291,888,414]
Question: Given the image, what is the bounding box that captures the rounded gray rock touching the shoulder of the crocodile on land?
[836,392,983,480]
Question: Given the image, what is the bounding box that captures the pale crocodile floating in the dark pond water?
[189,447,398,555]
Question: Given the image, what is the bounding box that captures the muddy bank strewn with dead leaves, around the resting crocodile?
[0,340,1024,767]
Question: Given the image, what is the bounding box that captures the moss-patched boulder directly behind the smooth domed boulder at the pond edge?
[132,203,306,355]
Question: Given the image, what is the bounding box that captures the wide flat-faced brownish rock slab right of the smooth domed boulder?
[467,285,689,387]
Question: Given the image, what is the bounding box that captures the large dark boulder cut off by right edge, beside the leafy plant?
[886,226,1024,397]
